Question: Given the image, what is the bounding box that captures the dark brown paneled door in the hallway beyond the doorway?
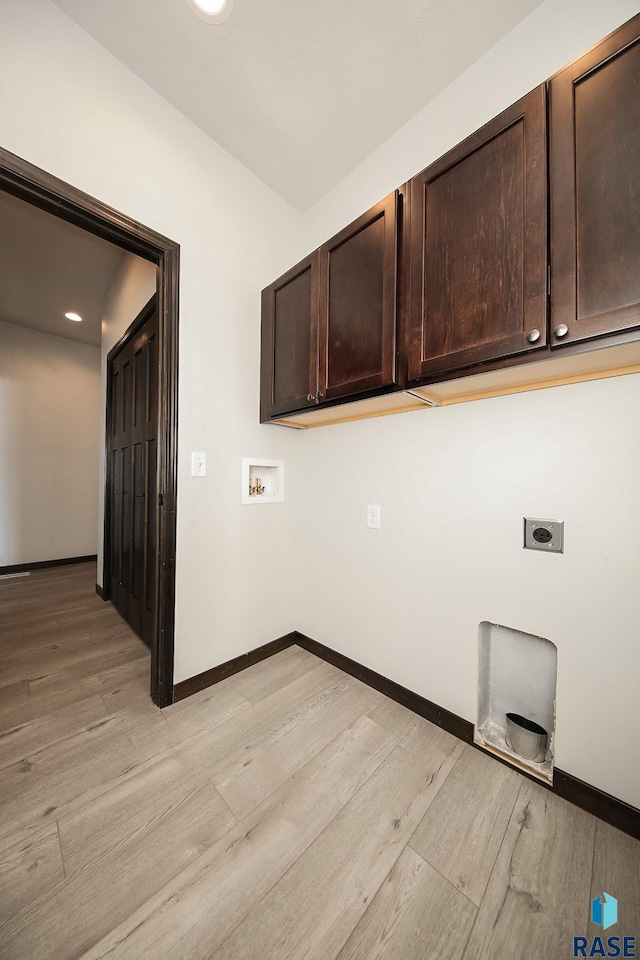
[106,297,159,645]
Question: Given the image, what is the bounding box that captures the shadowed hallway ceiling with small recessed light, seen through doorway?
[0,191,129,347]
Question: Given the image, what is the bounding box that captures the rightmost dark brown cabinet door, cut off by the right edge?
[550,16,640,346]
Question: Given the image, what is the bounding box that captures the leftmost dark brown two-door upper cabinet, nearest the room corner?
[260,191,399,421]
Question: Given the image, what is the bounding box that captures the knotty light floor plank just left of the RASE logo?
[464,780,596,960]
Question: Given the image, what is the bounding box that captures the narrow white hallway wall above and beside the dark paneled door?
[97,253,157,586]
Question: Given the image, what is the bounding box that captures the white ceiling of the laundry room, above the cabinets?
[48,0,542,212]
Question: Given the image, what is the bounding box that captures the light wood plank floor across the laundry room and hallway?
[0,564,640,960]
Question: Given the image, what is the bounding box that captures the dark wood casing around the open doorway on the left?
[0,147,180,707]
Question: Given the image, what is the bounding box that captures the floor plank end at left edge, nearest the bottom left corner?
[0,823,64,928]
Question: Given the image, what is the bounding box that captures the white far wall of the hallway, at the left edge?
[0,322,100,566]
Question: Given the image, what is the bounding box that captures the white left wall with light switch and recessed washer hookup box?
[0,0,301,681]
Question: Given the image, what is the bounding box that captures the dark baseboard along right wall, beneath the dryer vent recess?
[290,631,640,840]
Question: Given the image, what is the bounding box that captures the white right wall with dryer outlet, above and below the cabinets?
[297,0,640,806]
